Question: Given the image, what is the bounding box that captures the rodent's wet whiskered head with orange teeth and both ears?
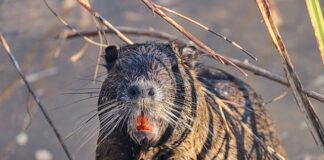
[98,43,197,146]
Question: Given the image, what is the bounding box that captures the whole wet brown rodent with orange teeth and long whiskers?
[96,42,285,160]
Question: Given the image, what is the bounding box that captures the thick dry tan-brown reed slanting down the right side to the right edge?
[256,0,324,151]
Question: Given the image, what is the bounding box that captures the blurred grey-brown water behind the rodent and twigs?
[0,0,324,160]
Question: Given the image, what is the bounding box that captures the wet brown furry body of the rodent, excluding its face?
[97,42,285,160]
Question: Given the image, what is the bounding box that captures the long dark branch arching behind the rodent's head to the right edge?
[66,26,324,103]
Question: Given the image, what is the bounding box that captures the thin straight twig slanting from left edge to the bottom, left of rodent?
[0,33,72,160]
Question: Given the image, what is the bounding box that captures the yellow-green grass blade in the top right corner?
[305,0,324,64]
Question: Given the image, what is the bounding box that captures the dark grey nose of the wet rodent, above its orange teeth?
[128,85,155,100]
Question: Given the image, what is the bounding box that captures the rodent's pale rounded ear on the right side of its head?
[180,46,199,69]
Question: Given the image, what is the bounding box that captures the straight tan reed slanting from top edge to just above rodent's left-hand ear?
[78,0,134,44]
